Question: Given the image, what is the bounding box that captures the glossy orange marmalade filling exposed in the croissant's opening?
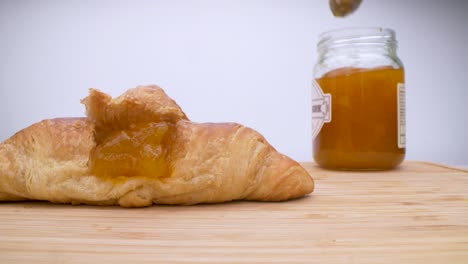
[89,122,174,178]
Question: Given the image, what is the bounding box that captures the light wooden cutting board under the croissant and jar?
[0,162,468,264]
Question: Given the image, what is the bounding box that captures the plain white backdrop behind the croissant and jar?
[0,0,468,165]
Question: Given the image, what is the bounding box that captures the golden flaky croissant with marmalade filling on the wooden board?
[0,86,314,207]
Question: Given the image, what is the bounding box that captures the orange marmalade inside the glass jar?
[313,67,405,169]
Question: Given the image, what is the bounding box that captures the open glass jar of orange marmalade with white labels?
[312,28,406,170]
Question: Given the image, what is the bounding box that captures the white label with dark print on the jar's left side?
[312,80,332,140]
